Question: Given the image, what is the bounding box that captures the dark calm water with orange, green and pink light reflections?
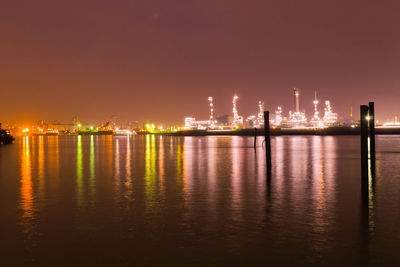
[0,135,400,266]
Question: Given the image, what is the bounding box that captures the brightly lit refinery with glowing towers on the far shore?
[184,88,338,130]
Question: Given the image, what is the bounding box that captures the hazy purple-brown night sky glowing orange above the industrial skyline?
[0,0,400,124]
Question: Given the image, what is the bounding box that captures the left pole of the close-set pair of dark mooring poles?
[360,105,368,185]
